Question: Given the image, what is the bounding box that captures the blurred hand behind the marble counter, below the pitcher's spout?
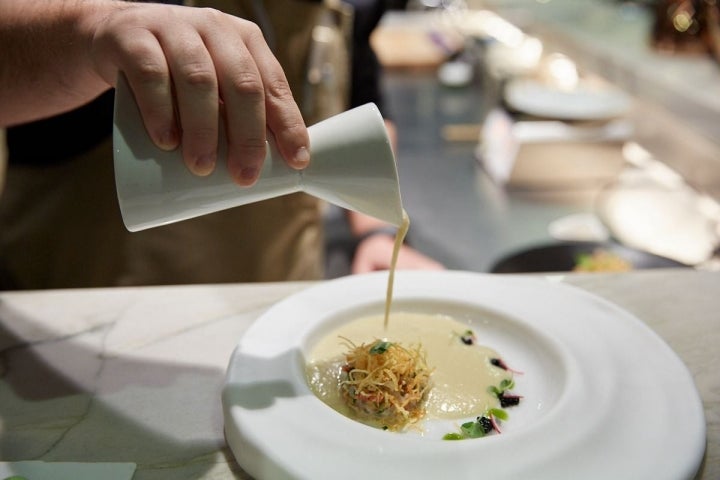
[352,234,445,274]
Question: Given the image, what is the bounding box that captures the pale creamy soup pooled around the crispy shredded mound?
[307,312,512,426]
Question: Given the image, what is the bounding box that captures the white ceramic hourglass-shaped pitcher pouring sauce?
[113,75,402,231]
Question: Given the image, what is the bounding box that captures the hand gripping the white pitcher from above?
[86,2,310,185]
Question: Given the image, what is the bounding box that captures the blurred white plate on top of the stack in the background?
[504,79,631,120]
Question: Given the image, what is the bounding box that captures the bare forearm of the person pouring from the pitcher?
[0,0,121,126]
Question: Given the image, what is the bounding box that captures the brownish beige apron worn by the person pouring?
[0,0,347,289]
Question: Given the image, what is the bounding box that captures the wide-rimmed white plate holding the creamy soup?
[223,272,705,480]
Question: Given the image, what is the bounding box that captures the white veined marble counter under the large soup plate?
[0,270,720,480]
